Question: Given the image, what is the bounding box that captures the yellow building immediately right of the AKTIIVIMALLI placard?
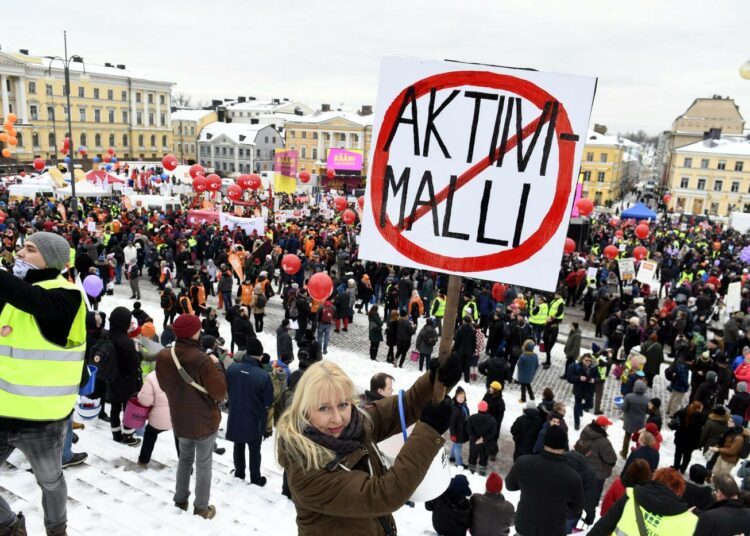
[581,130,640,206]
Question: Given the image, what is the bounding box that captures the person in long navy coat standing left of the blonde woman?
[227,338,280,486]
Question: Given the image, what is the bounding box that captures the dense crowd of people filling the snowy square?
[0,182,750,536]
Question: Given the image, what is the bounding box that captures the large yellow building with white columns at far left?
[0,50,174,163]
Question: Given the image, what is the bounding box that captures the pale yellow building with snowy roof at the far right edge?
[668,136,750,216]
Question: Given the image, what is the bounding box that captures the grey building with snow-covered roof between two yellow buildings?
[198,121,284,176]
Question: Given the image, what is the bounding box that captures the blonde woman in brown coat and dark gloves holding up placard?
[276,356,461,536]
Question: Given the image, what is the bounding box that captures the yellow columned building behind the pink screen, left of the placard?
[285,104,373,183]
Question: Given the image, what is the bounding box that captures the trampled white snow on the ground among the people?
[0,281,698,536]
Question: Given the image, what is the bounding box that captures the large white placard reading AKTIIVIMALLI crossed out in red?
[359,58,596,291]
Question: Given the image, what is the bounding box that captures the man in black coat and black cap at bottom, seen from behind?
[505,426,584,536]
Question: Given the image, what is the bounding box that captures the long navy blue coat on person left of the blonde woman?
[227,356,280,443]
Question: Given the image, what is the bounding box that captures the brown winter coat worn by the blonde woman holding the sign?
[278,373,445,536]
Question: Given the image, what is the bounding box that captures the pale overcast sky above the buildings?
[0,0,750,133]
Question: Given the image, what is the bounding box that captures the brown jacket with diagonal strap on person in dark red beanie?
[156,339,227,439]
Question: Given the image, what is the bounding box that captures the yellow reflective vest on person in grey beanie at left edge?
[0,276,86,421]
